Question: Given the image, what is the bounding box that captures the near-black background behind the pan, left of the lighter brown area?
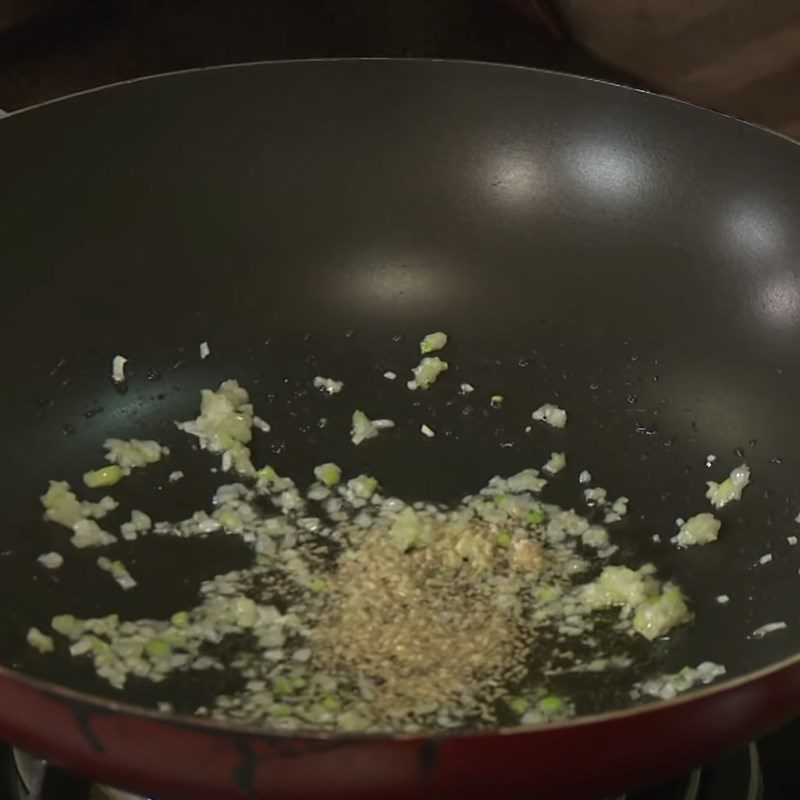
[0,0,632,111]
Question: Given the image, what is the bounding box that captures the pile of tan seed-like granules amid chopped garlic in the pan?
[314,523,525,721]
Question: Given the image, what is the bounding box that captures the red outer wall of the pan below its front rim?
[0,662,800,800]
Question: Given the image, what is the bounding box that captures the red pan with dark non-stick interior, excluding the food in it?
[0,61,800,797]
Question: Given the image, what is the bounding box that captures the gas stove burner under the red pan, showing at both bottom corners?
[0,744,764,800]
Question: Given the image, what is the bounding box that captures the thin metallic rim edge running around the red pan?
[0,57,800,744]
